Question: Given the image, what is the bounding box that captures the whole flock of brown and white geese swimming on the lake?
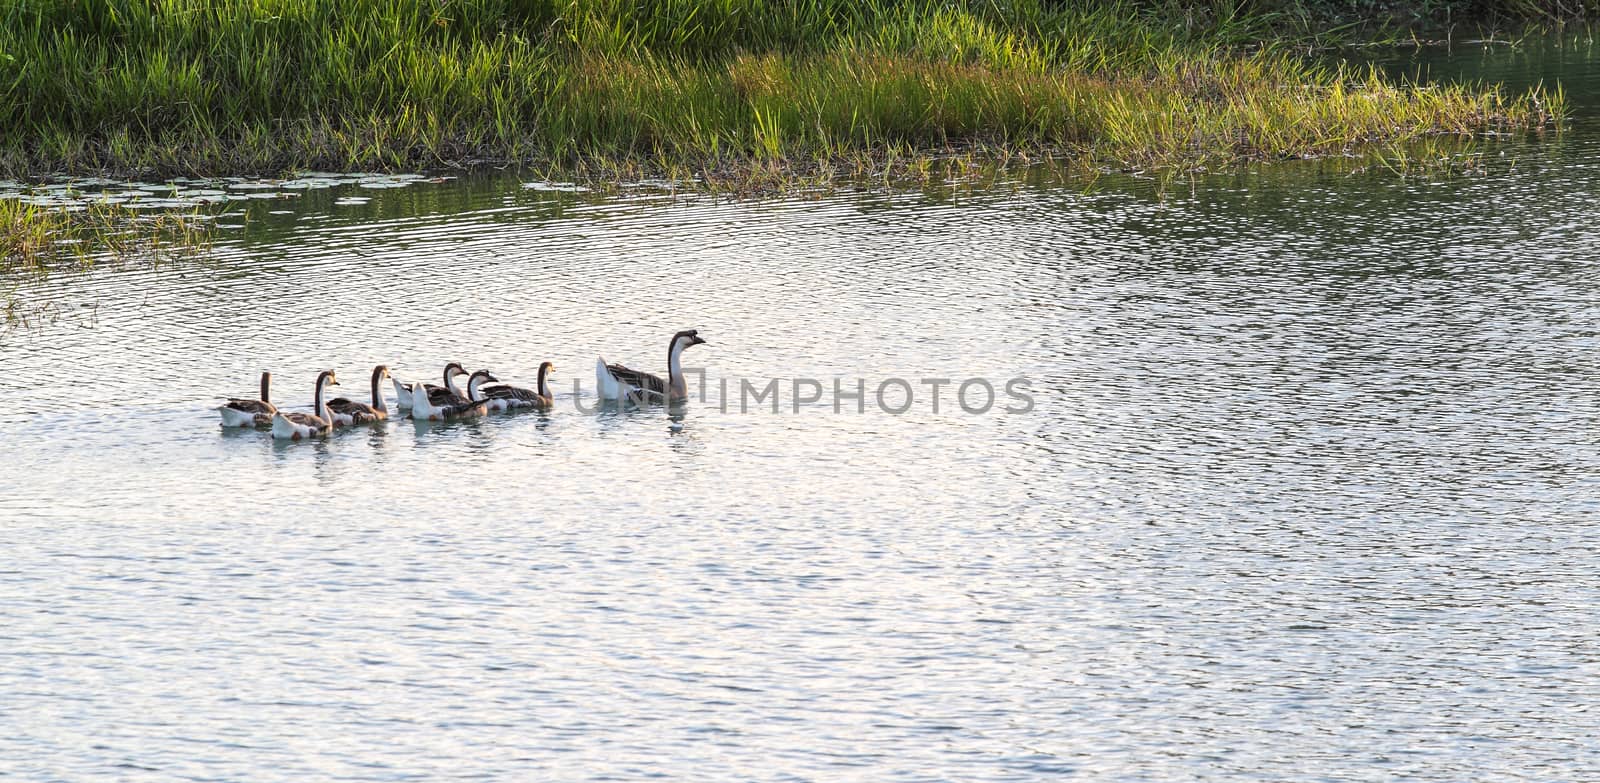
[216,328,706,440]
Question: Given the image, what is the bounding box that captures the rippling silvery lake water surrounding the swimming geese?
[0,45,1600,781]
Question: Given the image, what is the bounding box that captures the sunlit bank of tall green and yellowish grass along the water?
[0,0,1562,175]
